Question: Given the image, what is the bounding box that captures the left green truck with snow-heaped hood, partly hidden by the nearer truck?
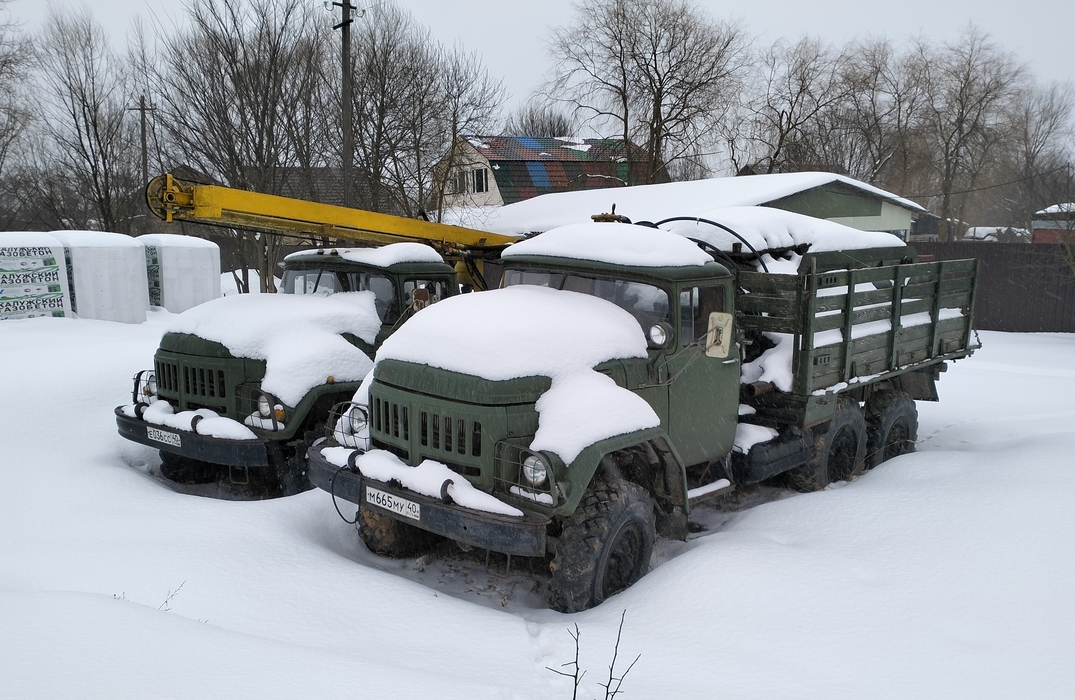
[115,243,459,497]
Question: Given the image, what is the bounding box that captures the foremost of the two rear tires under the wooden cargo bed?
[784,397,866,492]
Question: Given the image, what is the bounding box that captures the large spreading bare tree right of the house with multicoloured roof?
[547,0,747,183]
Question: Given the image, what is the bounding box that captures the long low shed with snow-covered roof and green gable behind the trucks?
[484,172,926,239]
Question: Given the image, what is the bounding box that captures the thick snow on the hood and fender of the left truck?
[168,291,381,406]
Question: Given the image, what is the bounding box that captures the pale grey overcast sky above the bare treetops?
[8,0,1075,110]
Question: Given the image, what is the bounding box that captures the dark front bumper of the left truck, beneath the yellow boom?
[114,406,272,467]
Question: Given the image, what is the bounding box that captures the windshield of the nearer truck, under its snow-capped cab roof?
[504,269,670,330]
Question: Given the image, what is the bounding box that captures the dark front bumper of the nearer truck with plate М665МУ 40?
[306,447,549,557]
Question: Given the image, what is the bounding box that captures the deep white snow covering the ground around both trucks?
[0,318,1075,700]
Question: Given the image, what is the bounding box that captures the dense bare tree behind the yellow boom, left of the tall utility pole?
[153,0,325,291]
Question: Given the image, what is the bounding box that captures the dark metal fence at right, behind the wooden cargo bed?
[914,243,1075,333]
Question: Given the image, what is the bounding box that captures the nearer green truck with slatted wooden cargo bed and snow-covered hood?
[309,216,977,612]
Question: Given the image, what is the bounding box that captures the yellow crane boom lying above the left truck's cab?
[145,174,516,257]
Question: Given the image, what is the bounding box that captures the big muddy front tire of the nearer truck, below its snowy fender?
[546,481,656,613]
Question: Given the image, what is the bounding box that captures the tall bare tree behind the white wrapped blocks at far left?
[35,9,138,232]
